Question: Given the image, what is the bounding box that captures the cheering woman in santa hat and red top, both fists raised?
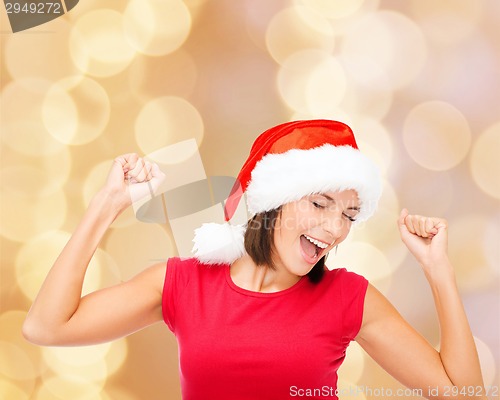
[23,120,486,400]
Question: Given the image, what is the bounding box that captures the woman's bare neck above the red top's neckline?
[230,255,301,293]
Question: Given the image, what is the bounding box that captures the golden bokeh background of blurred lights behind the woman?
[0,0,500,400]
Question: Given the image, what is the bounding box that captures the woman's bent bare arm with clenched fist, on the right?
[356,210,486,400]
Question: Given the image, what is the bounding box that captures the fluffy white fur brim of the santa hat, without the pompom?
[245,144,381,222]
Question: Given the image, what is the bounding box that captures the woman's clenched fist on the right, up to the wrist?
[398,209,449,272]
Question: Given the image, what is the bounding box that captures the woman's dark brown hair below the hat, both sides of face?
[245,207,325,283]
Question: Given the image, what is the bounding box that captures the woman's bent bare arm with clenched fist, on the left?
[23,154,165,346]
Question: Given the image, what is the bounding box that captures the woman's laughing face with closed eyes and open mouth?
[273,190,359,276]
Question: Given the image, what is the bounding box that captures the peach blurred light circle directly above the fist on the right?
[403,101,471,171]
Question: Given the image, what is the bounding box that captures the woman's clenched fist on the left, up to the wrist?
[103,153,165,212]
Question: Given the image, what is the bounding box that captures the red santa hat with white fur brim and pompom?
[193,120,381,264]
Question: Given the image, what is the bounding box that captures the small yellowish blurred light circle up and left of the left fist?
[42,77,110,145]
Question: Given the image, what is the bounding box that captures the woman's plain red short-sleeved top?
[163,258,368,400]
